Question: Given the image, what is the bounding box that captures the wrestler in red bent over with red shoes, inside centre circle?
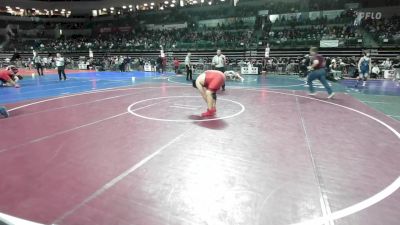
[193,70,225,117]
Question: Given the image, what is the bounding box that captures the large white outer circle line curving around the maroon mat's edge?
[0,86,400,225]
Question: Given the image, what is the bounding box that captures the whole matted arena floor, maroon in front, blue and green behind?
[0,72,400,225]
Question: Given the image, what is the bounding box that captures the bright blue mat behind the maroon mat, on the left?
[0,72,171,103]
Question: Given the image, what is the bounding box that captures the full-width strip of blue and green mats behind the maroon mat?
[0,71,400,104]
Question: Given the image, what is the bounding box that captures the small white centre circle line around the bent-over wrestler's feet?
[128,96,246,123]
